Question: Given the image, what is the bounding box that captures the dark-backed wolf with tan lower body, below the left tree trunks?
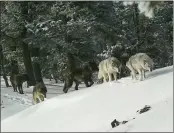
[33,82,47,104]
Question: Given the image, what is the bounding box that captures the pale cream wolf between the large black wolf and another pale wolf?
[98,57,121,82]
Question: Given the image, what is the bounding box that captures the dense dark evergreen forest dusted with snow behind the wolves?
[0,1,173,87]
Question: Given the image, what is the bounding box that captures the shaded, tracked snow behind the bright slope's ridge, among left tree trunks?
[1,77,85,120]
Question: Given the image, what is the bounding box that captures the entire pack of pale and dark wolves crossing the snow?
[10,53,154,104]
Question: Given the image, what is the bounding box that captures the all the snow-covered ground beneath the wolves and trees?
[1,66,173,132]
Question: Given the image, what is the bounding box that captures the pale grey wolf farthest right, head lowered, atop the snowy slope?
[126,53,154,81]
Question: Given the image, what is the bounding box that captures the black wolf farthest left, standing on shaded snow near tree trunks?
[10,73,29,94]
